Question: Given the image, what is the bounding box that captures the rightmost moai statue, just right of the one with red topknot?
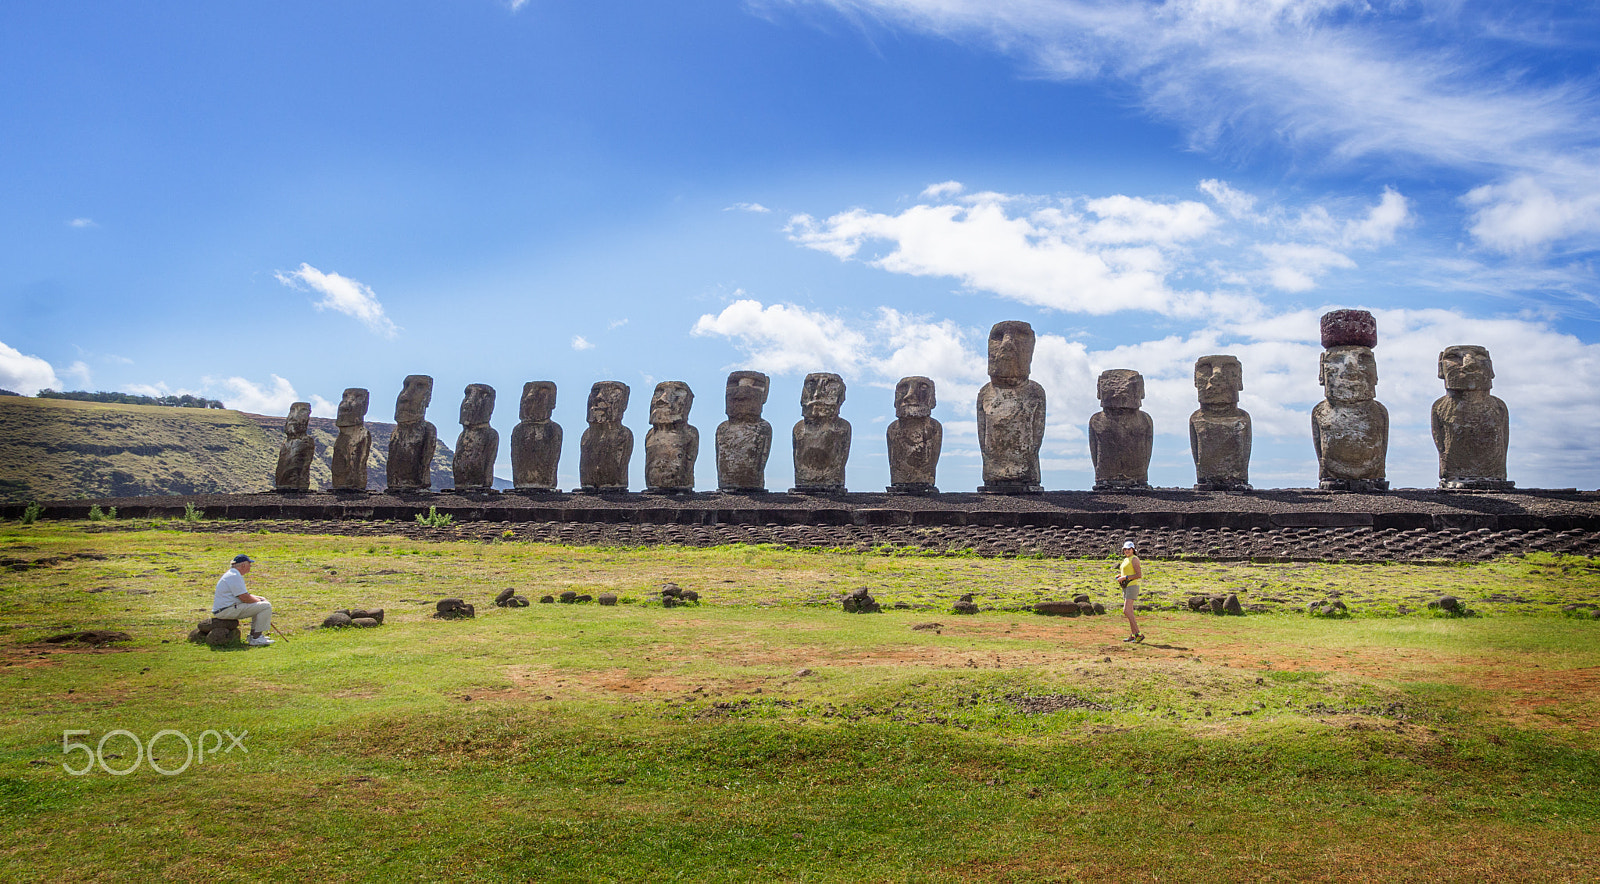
[1434,344,1517,492]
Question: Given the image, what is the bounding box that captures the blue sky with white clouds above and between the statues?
[0,0,1600,490]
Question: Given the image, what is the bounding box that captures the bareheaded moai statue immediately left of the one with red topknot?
[1189,356,1250,492]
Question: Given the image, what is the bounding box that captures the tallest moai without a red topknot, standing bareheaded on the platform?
[978,322,1045,495]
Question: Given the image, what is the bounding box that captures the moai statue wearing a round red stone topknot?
[1310,311,1389,492]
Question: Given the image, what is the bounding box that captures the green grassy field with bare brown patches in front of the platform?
[0,522,1600,881]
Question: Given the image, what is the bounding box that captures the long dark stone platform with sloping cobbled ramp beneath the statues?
[12,488,1600,562]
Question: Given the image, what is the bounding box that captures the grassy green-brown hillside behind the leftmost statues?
[0,396,451,503]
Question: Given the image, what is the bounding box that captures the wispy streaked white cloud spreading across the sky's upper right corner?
[789,0,1600,251]
